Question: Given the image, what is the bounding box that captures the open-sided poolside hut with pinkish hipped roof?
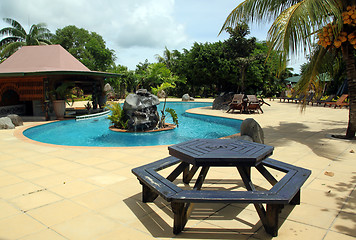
[0,45,119,116]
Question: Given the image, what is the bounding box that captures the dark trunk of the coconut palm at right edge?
[342,44,356,139]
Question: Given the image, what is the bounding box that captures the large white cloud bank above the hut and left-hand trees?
[0,0,187,68]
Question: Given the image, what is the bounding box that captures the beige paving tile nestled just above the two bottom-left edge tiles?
[27,200,90,226]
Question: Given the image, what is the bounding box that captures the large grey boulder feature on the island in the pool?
[123,89,160,132]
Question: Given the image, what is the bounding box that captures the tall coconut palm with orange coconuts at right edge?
[221,0,356,139]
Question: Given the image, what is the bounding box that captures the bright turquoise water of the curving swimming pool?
[24,102,242,147]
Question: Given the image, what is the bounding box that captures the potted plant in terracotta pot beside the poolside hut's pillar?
[52,82,74,119]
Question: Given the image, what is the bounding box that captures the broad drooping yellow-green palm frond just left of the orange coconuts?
[267,0,341,72]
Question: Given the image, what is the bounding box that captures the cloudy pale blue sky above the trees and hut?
[0,0,305,73]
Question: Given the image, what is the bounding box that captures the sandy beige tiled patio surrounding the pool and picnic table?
[0,100,356,240]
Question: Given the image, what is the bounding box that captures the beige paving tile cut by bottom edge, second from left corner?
[52,213,117,240]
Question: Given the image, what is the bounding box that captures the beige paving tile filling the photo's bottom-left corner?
[0,214,46,239]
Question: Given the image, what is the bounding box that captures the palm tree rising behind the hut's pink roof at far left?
[0,18,52,58]
